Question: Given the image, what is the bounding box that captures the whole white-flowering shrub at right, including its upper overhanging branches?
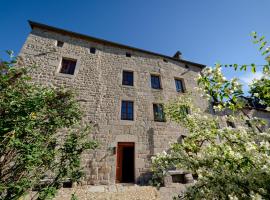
[152,33,270,199]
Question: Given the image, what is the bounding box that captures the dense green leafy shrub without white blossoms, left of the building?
[0,51,97,200]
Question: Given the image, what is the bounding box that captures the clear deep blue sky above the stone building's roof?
[0,0,270,91]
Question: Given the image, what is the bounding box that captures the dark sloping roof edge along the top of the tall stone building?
[28,20,206,69]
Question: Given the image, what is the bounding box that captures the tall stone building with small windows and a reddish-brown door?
[17,21,268,184]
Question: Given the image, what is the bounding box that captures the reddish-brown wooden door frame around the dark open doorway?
[115,142,136,183]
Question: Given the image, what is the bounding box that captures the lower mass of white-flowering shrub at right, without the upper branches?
[152,97,270,200]
